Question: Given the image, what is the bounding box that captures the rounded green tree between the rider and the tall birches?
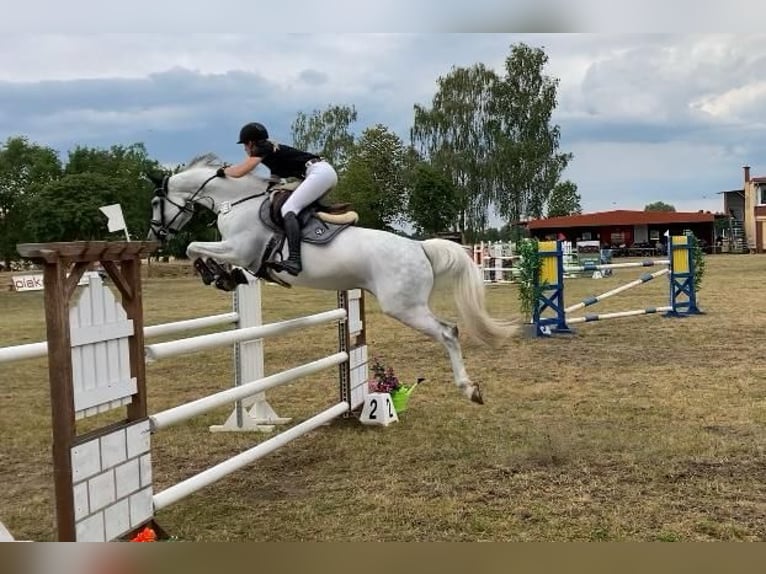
[333,124,409,229]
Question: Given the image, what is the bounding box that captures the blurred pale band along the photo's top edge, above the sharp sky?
[6,0,766,33]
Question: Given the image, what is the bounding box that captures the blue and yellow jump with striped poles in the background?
[533,235,701,337]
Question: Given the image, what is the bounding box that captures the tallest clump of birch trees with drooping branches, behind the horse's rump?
[410,43,572,236]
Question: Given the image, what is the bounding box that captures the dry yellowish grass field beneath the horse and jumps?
[0,255,766,541]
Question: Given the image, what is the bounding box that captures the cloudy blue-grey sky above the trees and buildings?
[0,18,766,220]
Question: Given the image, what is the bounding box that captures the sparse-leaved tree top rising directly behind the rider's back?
[290,105,357,172]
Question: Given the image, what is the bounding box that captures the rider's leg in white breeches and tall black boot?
[279,161,338,275]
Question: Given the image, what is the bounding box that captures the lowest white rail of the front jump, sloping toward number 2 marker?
[153,401,349,512]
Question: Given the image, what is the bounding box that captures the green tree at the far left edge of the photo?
[0,137,61,267]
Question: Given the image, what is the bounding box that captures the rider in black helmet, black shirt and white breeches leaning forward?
[218,122,338,275]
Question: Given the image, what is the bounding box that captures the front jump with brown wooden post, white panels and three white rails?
[10,242,367,542]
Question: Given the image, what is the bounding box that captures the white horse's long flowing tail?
[422,239,520,346]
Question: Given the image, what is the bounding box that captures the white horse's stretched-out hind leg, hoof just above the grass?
[381,302,484,404]
